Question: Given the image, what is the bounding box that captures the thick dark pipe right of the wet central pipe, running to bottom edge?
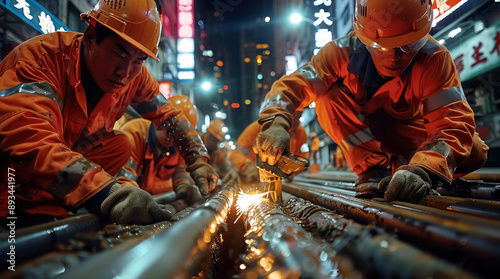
[283,195,475,278]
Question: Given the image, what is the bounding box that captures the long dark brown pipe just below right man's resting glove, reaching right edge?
[283,184,500,270]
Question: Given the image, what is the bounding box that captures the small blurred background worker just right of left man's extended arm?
[200,119,241,184]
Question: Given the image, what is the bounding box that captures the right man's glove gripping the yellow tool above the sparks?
[252,115,290,165]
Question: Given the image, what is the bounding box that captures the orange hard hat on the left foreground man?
[80,0,161,61]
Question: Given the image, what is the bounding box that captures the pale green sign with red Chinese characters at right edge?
[450,25,500,81]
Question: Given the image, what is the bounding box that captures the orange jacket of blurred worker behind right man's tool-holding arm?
[229,121,309,171]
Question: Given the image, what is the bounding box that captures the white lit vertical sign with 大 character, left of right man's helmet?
[312,0,335,54]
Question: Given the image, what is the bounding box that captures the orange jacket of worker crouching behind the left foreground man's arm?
[116,119,194,195]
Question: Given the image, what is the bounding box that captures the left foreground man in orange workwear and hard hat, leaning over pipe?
[0,0,218,226]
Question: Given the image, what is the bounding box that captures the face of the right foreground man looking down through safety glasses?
[367,47,418,77]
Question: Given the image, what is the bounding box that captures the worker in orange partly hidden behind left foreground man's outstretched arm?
[115,95,202,203]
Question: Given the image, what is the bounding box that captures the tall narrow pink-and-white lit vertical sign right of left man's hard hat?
[177,0,195,82]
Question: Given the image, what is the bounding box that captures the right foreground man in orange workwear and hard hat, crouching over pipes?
[254,0,489,202]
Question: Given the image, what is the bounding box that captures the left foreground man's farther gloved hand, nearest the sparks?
[186,159,219,195]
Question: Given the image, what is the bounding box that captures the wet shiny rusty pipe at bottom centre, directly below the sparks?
[239,200,362,278]
